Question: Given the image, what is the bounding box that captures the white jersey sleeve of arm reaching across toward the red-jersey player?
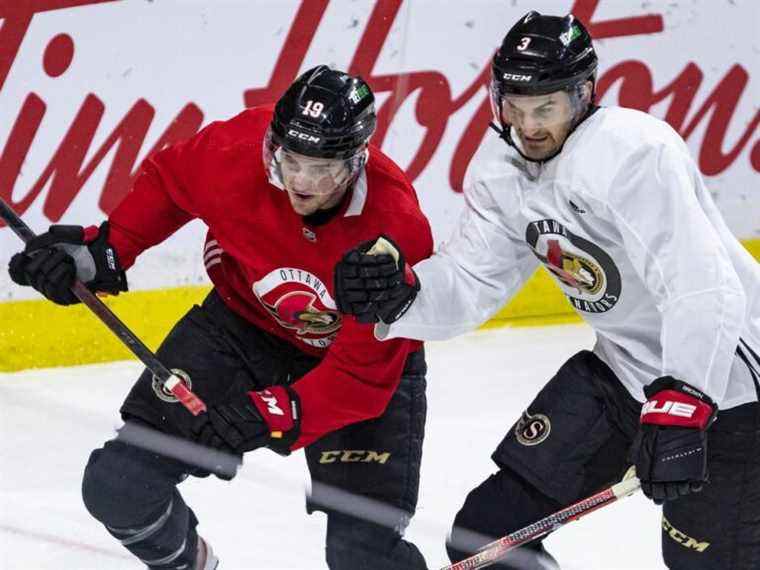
[375,182,538,340]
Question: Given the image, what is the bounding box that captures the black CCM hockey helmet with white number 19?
[270,65,377,159]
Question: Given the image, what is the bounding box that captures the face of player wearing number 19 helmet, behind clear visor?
[280,150,351,216]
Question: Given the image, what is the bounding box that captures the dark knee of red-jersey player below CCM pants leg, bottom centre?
[326,512,427,570]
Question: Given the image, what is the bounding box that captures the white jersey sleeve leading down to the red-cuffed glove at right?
[610,142,746,404]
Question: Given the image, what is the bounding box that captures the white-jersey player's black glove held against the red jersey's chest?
[335,236,420,324]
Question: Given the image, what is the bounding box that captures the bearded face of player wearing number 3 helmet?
[502,91,573,160]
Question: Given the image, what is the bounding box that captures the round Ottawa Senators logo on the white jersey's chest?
[525,220,621,313]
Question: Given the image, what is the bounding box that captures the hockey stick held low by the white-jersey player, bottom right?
[441,467,641,570]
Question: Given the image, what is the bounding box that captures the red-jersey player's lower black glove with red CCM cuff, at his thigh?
[193,386,301,455]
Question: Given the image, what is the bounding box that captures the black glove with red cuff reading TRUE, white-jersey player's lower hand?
[631,376,718,505]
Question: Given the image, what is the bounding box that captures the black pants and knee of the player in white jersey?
[448,351,760,570]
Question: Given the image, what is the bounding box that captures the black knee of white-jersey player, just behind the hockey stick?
[446,469,561,570]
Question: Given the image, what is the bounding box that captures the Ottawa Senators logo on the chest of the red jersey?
[252,267,342,348]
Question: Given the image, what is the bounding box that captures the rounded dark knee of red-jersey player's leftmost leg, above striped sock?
[82,441,183,527]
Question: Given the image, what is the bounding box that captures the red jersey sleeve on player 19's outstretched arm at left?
[104,127,209,269]
